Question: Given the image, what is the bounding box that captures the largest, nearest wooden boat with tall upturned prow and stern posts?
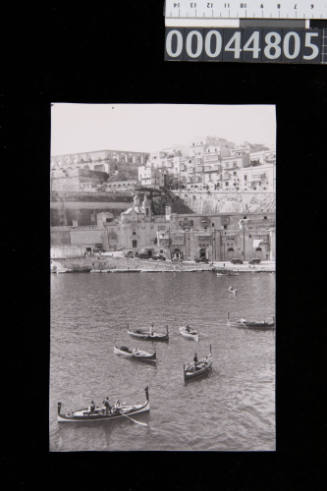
[57,387,150,423]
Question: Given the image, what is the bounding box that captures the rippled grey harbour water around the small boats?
[50,272,278,451]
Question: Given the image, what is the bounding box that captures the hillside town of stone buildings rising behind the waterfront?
[50,137,276,268]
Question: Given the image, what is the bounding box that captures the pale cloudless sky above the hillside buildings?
[51,103,276,155]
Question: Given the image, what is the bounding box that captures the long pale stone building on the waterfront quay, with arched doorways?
[104,195,275,261]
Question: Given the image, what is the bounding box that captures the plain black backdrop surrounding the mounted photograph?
[1,1,327,491]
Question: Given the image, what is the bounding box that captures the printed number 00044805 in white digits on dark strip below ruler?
[165,29,321,63]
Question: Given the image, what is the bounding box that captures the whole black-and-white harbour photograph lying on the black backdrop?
[49,102,278,452]
